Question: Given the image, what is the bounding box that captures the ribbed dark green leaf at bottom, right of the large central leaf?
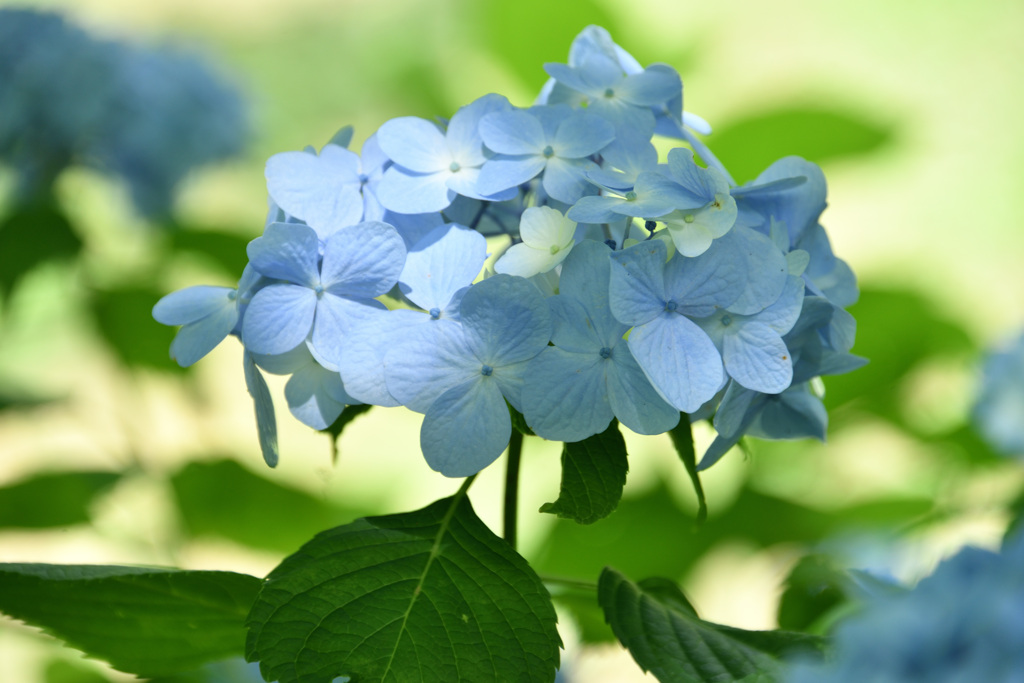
[598,568,822,683]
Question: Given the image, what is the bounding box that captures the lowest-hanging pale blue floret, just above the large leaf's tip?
[385,274,551,477]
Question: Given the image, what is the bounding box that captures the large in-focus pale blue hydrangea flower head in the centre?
[154,27,863,477]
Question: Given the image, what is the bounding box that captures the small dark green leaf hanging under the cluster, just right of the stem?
[541,420,629,524]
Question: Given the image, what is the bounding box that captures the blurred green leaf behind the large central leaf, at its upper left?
[171,460,370,552]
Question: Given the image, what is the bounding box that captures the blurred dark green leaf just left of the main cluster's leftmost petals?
[92,288,183,372]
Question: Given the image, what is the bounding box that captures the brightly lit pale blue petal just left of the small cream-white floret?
[398,224,487,311]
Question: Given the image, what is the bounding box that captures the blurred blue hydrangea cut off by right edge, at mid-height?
[973,334,1024,458]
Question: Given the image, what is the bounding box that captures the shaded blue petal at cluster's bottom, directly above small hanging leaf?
[522,346,612,441]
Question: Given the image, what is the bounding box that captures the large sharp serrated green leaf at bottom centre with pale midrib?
[247,489,560,683]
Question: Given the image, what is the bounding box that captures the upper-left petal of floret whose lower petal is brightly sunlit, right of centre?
[609,240,666,326]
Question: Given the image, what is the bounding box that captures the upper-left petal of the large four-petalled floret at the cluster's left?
[246,223,319,287]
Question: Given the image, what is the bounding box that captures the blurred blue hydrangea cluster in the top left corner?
[0,8,248,218]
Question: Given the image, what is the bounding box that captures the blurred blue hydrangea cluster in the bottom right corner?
[786,532,1024,683]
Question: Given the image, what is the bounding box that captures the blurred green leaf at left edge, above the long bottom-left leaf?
[0,472,121,528]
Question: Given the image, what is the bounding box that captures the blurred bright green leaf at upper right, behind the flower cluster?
[708,106,892,183]
